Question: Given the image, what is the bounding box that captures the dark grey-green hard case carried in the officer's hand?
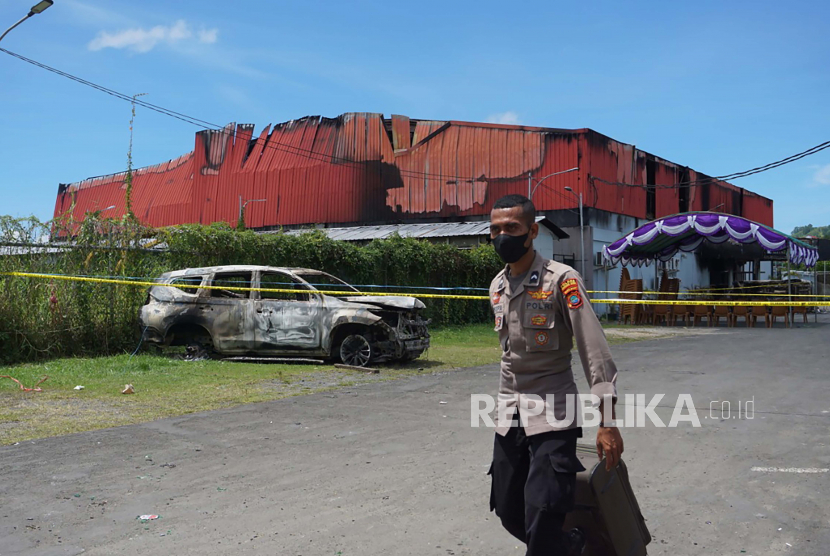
[564,444,651,556]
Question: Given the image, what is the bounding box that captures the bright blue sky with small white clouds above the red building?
[0,0,830,232]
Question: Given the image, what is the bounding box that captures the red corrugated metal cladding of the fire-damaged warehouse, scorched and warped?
[55,113,772,227]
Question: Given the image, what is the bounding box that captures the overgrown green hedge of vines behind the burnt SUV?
[0,213,502,363]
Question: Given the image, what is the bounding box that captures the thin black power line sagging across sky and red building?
[0,48,830,189]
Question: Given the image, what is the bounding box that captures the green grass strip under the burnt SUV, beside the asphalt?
[0,324,636,445]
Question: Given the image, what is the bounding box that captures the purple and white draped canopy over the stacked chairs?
[602,212,818,267]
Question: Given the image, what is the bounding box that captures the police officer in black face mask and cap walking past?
[490,195,623,556]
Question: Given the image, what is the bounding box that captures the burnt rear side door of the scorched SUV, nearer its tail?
[200,271,255,353]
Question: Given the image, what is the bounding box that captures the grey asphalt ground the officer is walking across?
[0,316,830,556]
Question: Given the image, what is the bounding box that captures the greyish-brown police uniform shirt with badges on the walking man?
[490,252,617,435]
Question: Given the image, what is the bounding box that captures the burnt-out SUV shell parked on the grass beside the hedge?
[139,265,429,367]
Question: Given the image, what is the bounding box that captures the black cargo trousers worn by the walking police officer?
[490,427,585,556]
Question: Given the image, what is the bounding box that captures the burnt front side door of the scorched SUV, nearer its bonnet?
[254,270,323,351]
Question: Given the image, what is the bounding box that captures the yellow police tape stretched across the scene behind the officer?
[0,272,830,307]
